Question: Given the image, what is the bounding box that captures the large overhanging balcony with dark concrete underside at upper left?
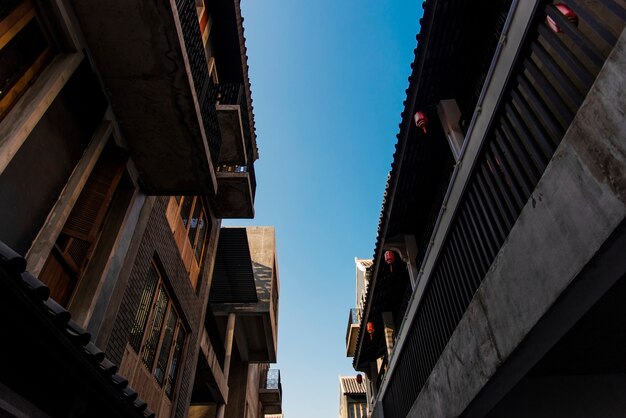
[72,0,222,194]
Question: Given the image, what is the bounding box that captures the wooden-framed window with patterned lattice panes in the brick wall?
[129,263,187,399]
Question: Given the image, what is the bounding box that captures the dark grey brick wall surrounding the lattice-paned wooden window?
[106,197,212,418]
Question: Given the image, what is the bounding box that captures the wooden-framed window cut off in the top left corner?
[0,0,52,119]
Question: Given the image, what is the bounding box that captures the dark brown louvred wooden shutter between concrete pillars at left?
[40,145,126,305]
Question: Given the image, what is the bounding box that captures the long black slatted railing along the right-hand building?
[383,0,626,418]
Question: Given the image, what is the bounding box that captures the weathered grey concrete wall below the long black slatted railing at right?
[409,27,626,417]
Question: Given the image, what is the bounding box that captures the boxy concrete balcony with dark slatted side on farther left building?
[209,227,279,362]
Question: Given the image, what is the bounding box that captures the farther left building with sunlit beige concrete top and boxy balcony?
[190,227,282,418]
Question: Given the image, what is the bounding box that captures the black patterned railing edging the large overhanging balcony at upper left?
[176,0,222,166]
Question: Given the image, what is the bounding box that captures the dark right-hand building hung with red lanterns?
[353,0,626,418]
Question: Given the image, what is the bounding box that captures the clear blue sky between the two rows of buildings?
[225,0,422,418]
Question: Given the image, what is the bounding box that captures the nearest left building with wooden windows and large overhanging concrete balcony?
[0,0,264,417]
